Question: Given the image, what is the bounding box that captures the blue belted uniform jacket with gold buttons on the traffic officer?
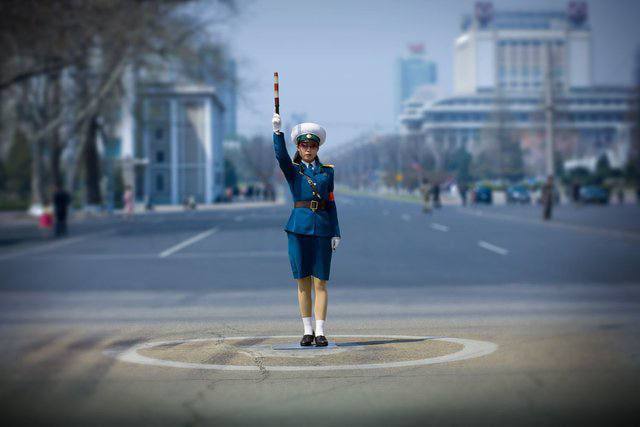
[273,132,340,237]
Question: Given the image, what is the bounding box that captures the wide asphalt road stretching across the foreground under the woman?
[0,195,640,425]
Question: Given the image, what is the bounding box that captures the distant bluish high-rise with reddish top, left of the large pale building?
[395,44,438,116]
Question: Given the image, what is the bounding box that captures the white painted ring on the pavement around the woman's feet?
[105,335,498,371]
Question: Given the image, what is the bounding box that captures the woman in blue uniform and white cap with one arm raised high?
[272,114,340,347]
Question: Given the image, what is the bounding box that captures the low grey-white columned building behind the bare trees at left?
[136,85,224,204]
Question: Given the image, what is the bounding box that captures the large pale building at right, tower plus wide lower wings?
[400,2,633,175]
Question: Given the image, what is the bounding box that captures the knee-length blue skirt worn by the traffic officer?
[287,231,333,280]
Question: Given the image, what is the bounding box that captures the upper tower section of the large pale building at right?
[454,2,592,93]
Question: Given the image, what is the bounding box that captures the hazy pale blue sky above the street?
[218,0,640,148]
